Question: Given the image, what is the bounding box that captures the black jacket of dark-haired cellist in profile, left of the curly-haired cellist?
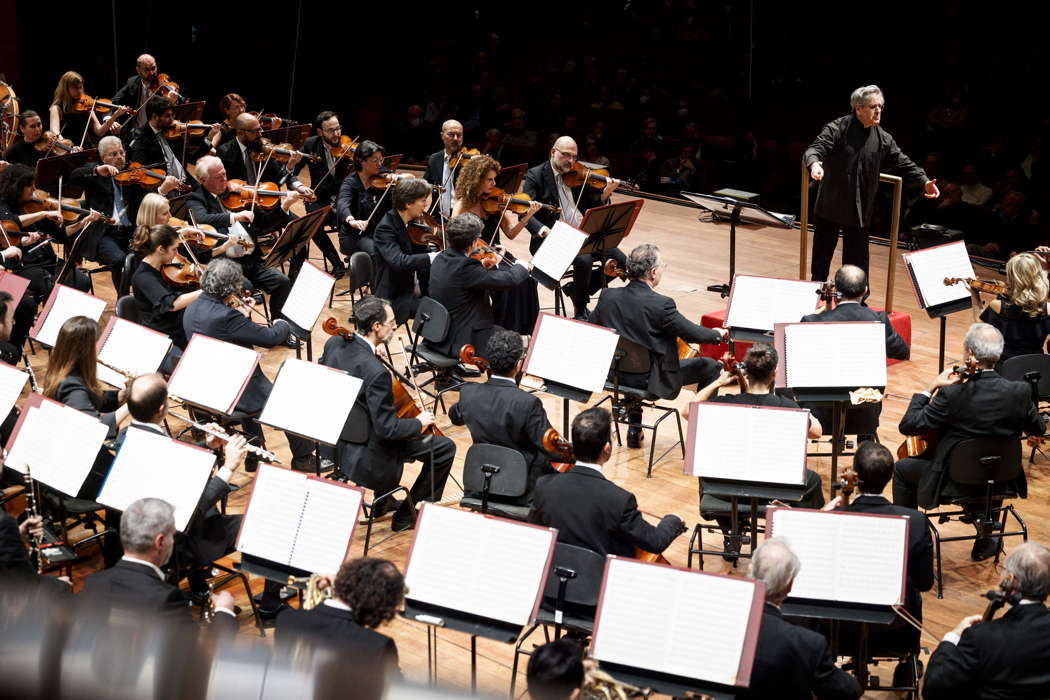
[318,335,423,488]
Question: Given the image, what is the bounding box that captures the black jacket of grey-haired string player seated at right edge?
[899,369,1044,508]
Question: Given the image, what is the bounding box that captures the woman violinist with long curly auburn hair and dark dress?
[453,155,540,336]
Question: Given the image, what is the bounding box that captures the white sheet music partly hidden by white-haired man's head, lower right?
[771,508,908,606]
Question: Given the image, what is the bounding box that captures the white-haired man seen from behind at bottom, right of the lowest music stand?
[736,537,863,700]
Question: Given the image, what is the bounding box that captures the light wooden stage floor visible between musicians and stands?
[49,195,1033,697]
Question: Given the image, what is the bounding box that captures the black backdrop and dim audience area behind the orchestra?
[0,0,1050,241]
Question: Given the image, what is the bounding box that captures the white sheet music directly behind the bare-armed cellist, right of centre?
[686,401,810,485]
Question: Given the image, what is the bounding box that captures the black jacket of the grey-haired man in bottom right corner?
[923,602,1050,700]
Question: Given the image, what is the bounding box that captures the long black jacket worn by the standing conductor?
[802,113,929,228]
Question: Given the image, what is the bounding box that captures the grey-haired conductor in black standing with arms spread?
[802,85,941,281]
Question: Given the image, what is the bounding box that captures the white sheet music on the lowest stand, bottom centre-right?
[593,558,761,685]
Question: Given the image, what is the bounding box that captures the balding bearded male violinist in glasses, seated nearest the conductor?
[522,136,625,319]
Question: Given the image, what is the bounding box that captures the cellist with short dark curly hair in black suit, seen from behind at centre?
[448,328,567,506]
